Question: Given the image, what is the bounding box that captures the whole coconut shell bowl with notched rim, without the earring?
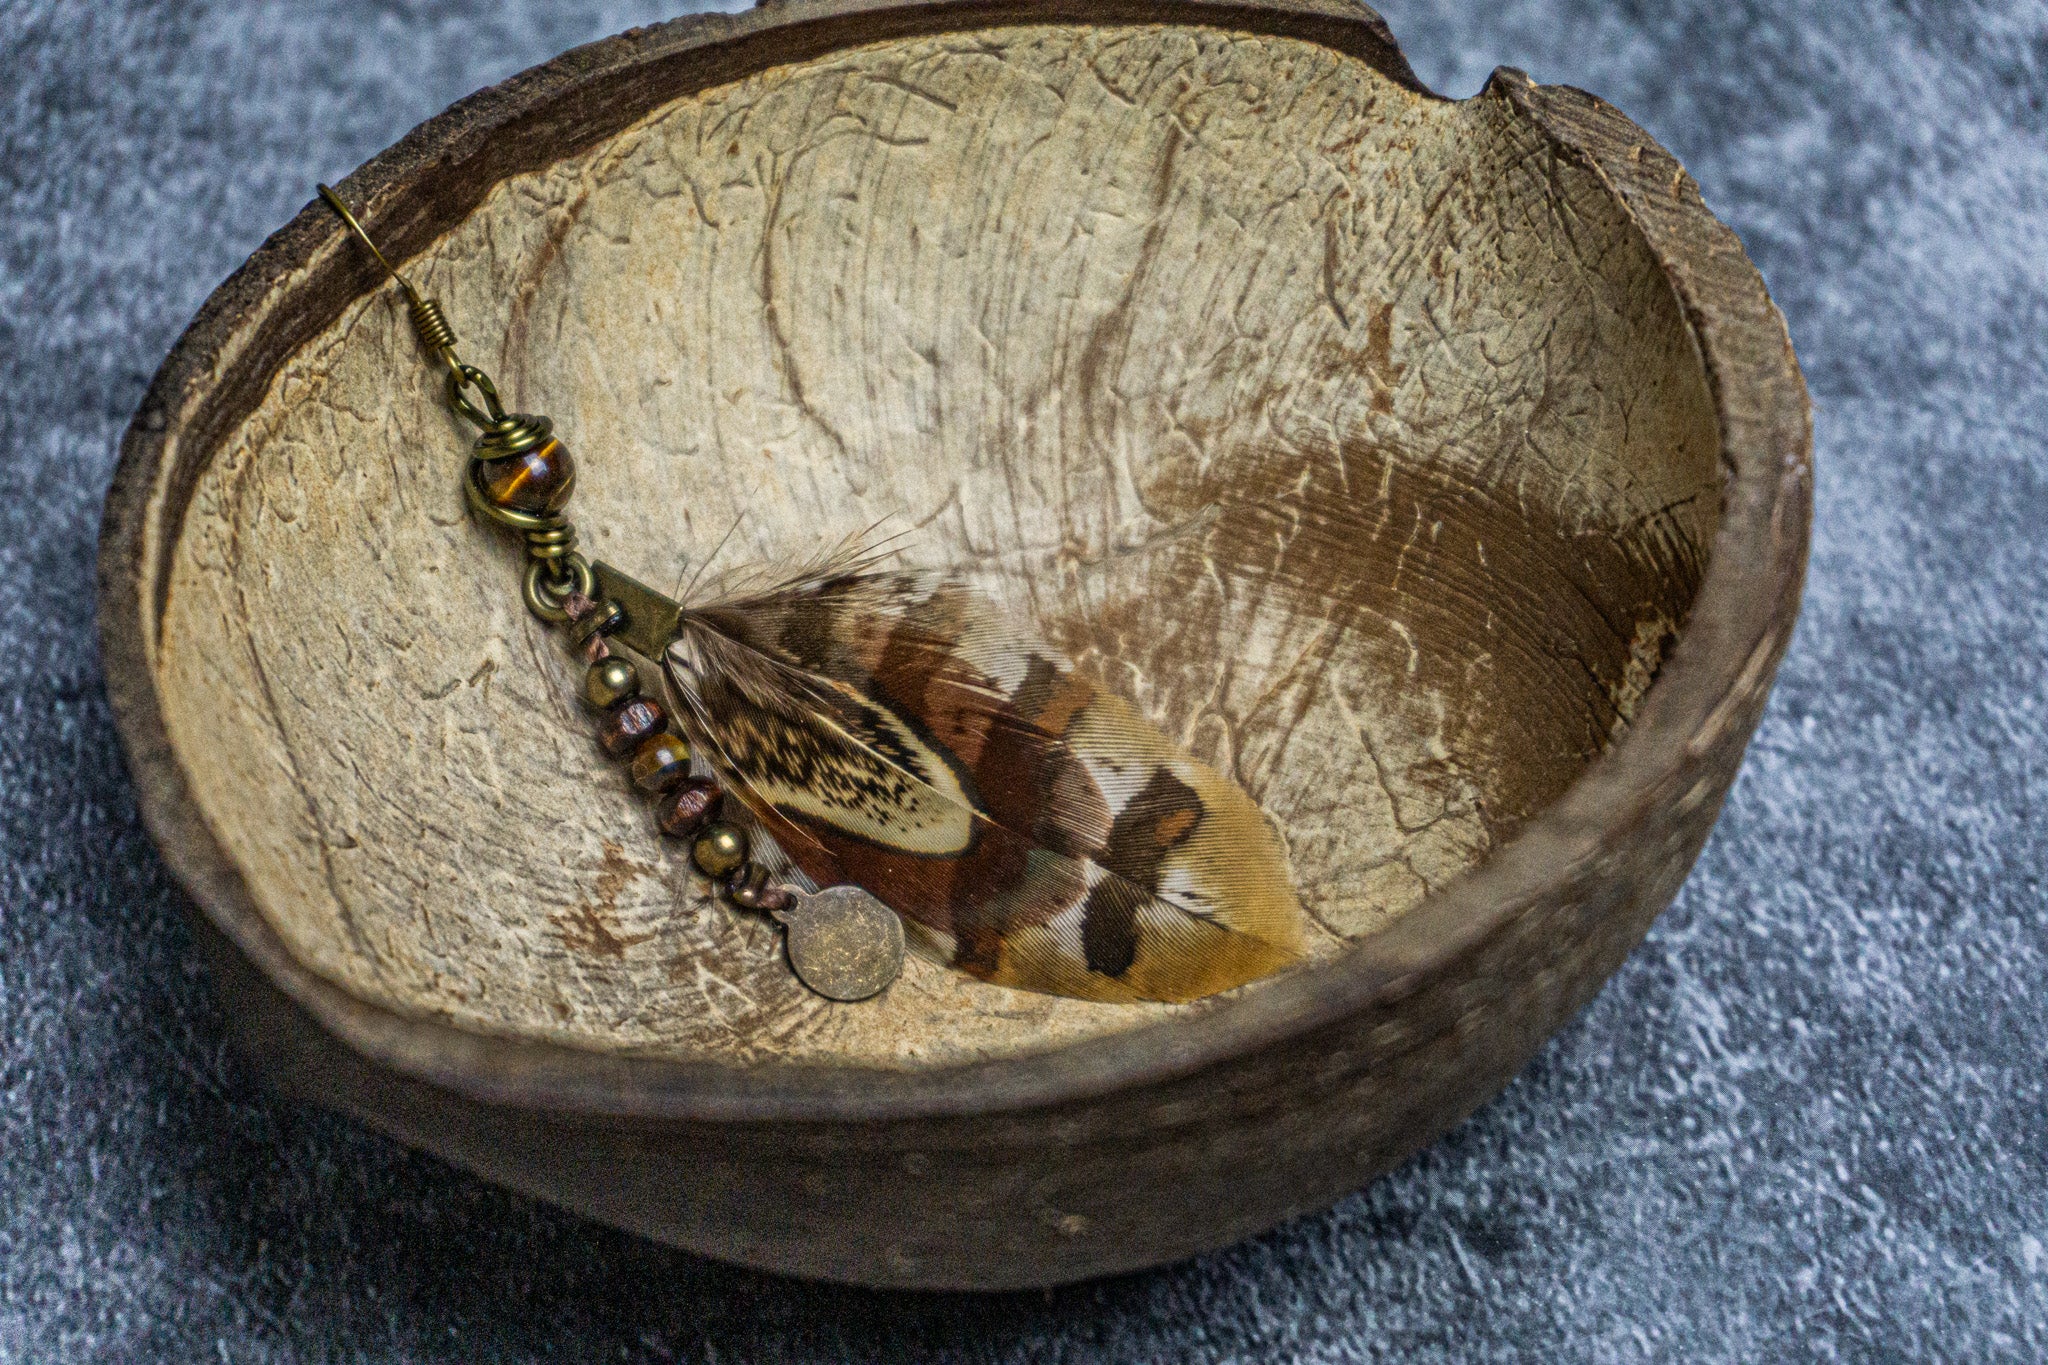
[100,0,1810,1289]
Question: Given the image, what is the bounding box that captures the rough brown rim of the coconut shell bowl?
[98,0,1812,1121]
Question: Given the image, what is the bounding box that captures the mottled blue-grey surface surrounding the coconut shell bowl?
[0,0,2048,1363]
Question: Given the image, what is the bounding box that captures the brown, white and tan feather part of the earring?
[664,546,1305,1001]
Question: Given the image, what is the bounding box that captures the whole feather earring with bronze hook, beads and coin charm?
[319,186,1305,1001]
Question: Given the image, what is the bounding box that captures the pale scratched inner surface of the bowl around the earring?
[158,25,1720,1066]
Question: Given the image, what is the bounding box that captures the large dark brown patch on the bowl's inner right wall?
[1053,394,1714,845]
